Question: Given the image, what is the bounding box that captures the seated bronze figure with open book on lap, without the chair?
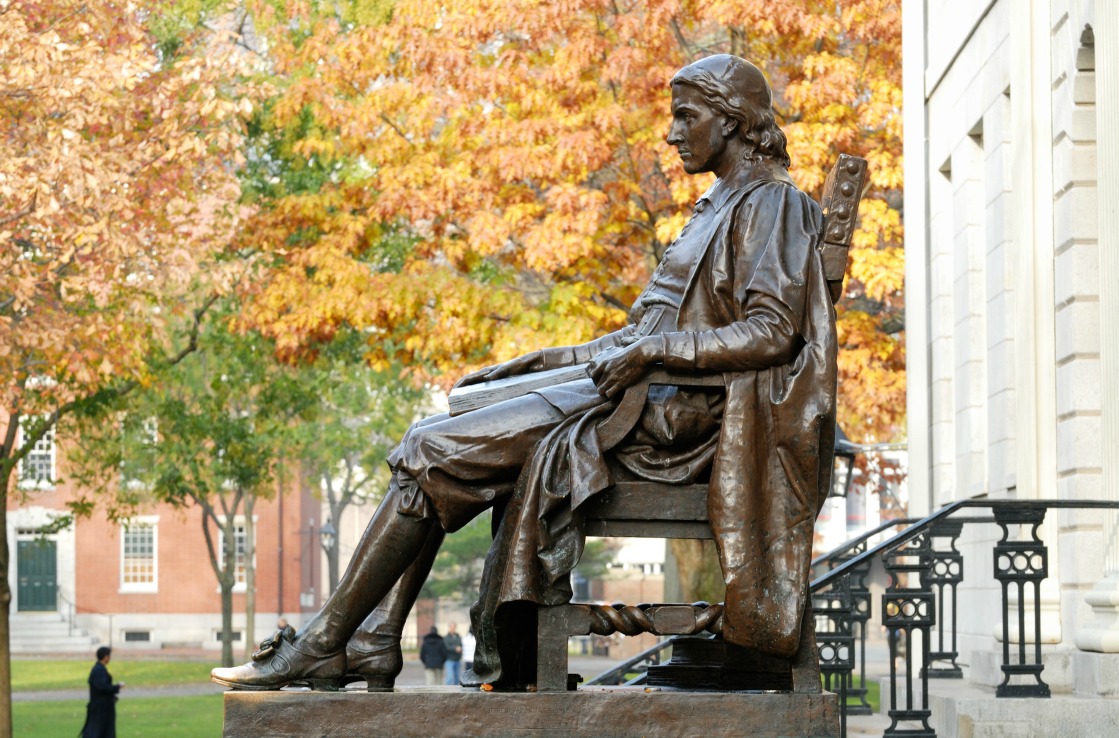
[213,55,849,690]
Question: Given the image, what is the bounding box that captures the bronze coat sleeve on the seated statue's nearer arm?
[664,182,820,371]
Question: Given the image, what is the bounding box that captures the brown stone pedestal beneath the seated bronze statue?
[223,687,839,738]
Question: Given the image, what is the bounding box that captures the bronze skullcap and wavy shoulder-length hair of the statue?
[669,54,790,173]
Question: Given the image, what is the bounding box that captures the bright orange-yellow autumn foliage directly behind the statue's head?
[241,0,904,441]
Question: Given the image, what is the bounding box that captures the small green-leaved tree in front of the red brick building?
[69,309,317,665]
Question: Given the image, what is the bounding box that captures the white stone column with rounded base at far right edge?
[1075,0,1119,653]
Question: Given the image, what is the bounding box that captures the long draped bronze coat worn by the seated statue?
[472,161,837,682]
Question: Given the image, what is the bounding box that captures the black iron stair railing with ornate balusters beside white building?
[809,500,1119,738]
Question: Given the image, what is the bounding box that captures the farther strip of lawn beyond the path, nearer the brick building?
[11,657,220,692]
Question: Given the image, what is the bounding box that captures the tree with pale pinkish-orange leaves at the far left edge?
[0,0,256,720]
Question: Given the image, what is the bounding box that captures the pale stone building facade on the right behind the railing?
[903,0,1119,735]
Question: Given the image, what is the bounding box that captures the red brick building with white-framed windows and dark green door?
[8,415,326,653]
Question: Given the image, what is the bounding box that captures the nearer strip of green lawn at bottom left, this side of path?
[11,694,222,738]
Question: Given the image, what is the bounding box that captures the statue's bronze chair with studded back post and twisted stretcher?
[536,154,866,692]
